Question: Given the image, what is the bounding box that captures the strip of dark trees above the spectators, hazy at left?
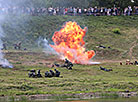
[0,0,138,8]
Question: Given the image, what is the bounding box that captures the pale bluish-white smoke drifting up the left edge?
[0,0,29,68]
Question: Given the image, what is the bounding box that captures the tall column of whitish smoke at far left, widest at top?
[0,0,31,68]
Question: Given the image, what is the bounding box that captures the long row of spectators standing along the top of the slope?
[0,6,138,16]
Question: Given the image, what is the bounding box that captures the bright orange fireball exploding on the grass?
[50,21,95,64]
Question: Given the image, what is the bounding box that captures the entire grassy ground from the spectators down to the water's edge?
[0,16,138,99]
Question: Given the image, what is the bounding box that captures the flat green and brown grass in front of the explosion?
[0,52,138,96]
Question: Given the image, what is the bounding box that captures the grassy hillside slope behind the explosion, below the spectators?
[3,15,138,60]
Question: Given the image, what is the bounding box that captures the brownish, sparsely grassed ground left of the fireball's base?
[4,51,62,67]
